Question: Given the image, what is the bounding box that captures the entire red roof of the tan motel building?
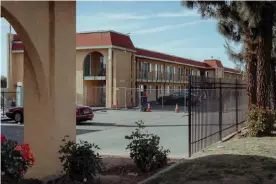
[12,31,240,73]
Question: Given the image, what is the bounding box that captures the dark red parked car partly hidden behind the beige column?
[6,105,94,123]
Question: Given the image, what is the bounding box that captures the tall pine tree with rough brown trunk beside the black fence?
[181,1,276,107]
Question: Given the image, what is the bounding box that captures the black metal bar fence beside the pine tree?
[188,76,248,156]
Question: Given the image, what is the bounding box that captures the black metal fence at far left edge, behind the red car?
[1,91,16,116]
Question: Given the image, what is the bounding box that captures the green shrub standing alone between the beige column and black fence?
[125,121,170,172]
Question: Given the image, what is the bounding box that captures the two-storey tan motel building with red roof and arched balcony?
[7,31,242,108]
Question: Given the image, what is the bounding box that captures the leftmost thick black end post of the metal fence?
[188,75,192,157]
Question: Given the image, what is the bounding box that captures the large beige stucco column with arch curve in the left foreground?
[1,1,76,179]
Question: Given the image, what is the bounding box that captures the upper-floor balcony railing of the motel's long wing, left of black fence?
[137,70,191,83]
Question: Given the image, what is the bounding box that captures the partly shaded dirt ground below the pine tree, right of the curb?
[144,136,276,184]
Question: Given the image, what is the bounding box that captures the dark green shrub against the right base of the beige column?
[59,136,103,183]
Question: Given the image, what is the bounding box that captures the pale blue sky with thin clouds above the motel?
[1,1,238,75]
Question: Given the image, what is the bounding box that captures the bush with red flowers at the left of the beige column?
[1,135,35,181]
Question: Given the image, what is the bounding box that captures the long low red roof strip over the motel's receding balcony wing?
[136,48,209,67]
